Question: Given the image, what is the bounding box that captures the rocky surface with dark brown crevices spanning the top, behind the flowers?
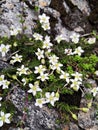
[0,0,96,36]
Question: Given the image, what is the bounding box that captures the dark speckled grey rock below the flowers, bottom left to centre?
[10,88,60,130]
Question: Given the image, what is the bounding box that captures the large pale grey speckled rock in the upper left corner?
[0,0,37,37]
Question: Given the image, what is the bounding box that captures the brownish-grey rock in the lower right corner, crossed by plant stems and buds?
[78,79,98,130]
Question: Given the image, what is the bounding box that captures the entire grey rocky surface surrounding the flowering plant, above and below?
[0,0,98,130]
